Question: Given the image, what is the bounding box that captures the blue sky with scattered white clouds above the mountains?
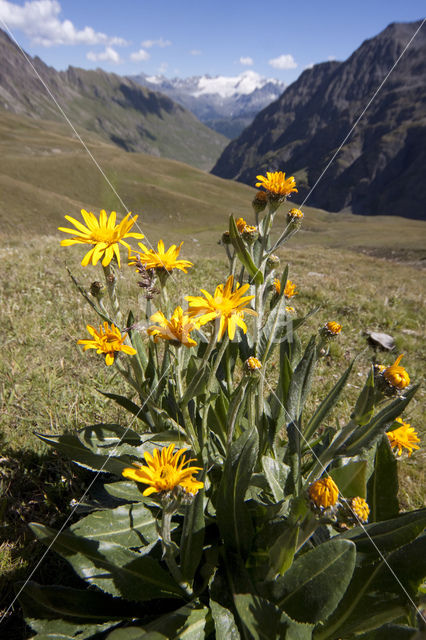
[0,0,426,84]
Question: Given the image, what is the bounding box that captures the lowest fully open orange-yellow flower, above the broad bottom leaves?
[122,444,204,496]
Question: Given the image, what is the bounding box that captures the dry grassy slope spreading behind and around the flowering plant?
[0,110,426,637]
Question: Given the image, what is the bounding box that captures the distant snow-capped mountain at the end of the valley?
[131,71,285,139]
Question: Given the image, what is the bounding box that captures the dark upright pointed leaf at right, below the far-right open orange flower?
[367,434,399,522]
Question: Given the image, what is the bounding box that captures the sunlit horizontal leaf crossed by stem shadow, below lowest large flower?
[70,503,159,547]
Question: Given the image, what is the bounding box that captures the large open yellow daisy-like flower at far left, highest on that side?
[58,209,144,267]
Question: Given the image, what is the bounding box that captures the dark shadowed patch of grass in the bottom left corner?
[0,436,89,640]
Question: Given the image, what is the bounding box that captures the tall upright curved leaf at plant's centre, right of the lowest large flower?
[216,428,258,556]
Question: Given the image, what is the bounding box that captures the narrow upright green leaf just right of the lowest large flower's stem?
[180,488,205,581]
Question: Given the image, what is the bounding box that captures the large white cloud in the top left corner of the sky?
[0,0,128,47]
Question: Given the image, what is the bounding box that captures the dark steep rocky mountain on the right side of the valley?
[212,21,426,219]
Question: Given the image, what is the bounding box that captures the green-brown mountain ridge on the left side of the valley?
[0,30,226,170]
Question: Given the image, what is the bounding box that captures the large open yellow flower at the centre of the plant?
[185,276,257,340]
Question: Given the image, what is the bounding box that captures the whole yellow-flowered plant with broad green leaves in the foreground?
[20,172,426,640]
